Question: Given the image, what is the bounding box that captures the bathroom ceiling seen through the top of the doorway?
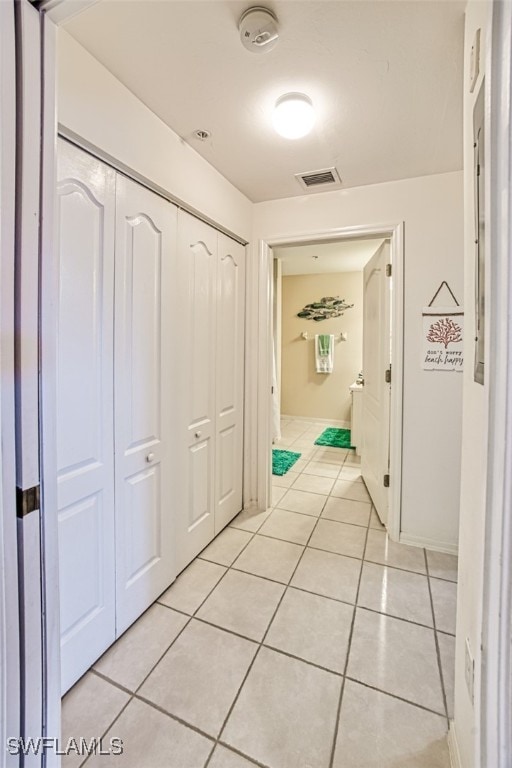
[272,238,384,276]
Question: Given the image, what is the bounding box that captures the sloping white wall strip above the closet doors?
[57,29,252,240]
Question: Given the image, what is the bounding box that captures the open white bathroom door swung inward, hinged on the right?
[361,242,391,524]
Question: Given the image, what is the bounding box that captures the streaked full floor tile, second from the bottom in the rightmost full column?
[347,608,444,714]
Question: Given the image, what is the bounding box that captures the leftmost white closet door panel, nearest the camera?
[56,141,115,692]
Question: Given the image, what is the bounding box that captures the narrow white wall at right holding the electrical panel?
[455,2,491,768]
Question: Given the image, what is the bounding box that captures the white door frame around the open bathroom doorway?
[256,222,404,541]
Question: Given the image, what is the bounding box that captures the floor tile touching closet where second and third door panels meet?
[158,560,226,614]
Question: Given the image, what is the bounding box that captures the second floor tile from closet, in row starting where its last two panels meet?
[234,535,304,584]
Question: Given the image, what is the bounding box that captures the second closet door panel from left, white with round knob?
[115,174,178,635]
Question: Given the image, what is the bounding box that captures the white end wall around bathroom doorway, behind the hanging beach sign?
[253,172,463,551]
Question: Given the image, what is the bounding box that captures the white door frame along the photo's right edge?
[479,2,512,768]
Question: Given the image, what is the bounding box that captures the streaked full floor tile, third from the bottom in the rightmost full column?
[357,563,433,627]
